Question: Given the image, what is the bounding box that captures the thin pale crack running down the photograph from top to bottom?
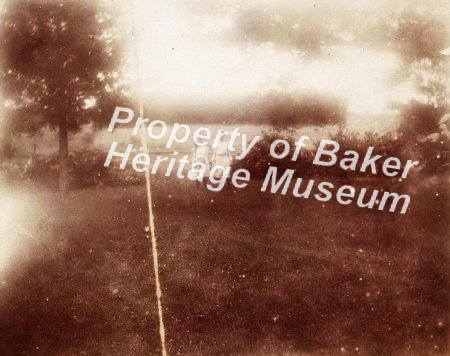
[131,0,167,356]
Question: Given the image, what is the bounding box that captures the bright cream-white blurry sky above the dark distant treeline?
[122,0,446,131]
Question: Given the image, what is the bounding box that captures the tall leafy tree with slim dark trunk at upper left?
[0,0,122,191]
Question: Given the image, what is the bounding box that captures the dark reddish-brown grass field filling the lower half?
[0,172,449,355]
